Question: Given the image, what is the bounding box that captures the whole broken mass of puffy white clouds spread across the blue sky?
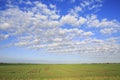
[0,0,120,53]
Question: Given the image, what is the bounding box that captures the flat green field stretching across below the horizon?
[0,64,120,80]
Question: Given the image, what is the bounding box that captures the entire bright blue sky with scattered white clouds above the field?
[0,0,120,64]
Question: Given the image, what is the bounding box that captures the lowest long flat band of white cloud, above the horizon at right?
[49,44,120,54]
